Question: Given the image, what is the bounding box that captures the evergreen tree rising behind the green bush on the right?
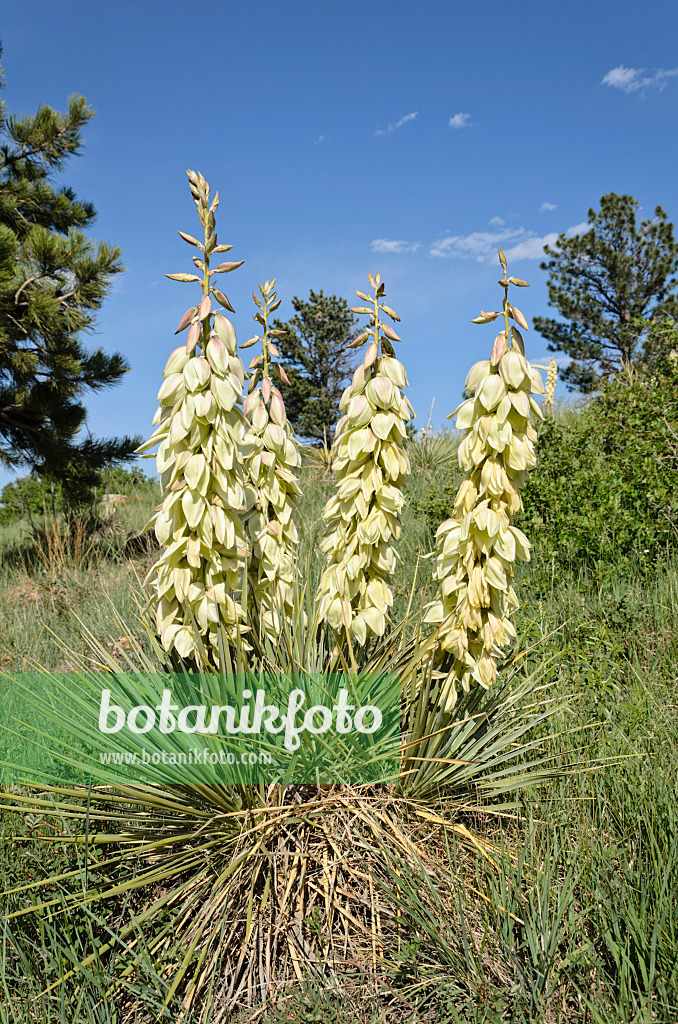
[534,193,678,392]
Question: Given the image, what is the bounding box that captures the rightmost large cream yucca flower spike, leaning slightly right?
[425,249,544,708]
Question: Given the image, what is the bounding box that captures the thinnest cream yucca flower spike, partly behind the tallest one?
[241,281,301,639]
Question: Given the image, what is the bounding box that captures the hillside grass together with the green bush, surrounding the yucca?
[0,358,678,1024]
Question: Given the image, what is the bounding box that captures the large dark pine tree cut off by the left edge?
[0,41,139,499]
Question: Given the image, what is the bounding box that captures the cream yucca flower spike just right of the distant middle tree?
[317,274,413,644]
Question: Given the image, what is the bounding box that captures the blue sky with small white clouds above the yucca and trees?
[0,0,678,482]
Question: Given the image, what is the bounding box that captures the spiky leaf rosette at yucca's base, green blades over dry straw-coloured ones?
[0,609,573,1024]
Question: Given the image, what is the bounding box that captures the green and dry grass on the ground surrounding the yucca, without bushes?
[0,450,678,1024]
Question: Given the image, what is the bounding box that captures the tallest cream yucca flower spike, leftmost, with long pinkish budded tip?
[138,171,247,658]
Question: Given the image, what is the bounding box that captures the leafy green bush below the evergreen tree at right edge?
[520,346,678,569]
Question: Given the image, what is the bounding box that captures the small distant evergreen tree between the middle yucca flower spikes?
[276,291,356,444]
